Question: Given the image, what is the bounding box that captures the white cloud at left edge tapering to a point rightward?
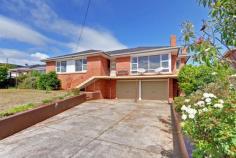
[0,16,53,45]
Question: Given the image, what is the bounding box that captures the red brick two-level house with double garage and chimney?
[43,35,188,102]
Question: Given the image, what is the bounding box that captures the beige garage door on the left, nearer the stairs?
[116,81,138,99]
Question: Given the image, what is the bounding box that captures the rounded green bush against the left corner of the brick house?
[37,72,60,90]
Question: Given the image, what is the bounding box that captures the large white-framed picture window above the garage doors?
[131,54,169,73]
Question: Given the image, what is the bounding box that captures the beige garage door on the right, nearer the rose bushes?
[141,81,168,100]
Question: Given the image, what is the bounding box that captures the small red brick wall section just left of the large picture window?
[116,56,130,73]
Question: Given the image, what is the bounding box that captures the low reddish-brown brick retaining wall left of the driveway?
[0,94,86,140]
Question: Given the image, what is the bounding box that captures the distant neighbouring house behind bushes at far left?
[9,65,46,78]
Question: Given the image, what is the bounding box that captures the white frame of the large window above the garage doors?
[130,53,171,75]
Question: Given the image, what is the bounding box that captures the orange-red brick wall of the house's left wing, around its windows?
[46,56,109,89]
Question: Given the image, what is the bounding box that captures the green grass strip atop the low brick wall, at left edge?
[0,103,36,117]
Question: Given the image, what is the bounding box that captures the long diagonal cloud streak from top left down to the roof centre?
[0,0,126,51]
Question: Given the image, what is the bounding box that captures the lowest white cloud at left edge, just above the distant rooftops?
[0,48,48,65]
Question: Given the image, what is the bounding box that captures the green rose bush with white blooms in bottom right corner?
[179,91,236,158]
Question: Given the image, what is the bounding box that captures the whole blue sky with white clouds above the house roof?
[0,0,208,65]
